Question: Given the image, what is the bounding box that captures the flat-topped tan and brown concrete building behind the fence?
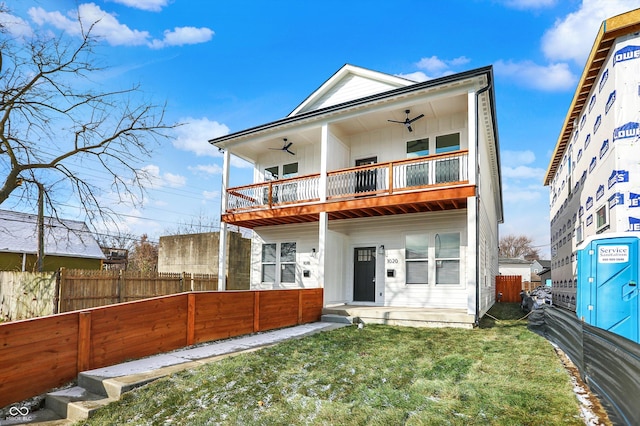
[158,232,251,290]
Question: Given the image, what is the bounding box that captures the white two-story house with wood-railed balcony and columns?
[210,65,503,324]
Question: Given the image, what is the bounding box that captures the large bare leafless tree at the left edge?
[0,10,175,224]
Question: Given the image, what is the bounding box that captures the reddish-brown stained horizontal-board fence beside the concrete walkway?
[0,288,323,407]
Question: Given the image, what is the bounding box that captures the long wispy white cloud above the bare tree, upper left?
[29,0,214,49]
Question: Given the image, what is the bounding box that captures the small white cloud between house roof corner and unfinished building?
[494,60,577,91]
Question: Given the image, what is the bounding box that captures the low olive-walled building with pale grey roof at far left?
[0,210,105,271]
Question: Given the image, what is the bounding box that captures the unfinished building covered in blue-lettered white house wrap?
[544,9,640,310]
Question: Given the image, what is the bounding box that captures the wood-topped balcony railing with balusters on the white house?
[227,150,469,211]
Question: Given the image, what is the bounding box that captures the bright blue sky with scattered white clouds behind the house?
[2,0,640,256]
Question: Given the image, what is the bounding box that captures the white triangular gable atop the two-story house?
[288,64,416,117]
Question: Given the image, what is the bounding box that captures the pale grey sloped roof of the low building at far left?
[0,210,105,259]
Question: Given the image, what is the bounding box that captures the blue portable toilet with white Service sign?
[576,233,640,343]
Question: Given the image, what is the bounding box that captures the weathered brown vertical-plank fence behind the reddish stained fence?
[58,268,218,312]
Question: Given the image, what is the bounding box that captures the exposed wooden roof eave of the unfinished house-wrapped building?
[544,9,640,186]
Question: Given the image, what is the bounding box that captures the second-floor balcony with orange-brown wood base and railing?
[222,150,475,228]
